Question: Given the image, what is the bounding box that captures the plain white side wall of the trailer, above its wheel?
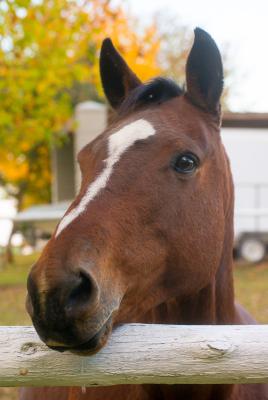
[222,128,268,234]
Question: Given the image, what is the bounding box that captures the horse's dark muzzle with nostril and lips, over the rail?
[26,270,117,354]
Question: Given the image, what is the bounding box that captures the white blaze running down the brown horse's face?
[56,119,155,237]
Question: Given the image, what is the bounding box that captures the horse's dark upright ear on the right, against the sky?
[186,28,223,113]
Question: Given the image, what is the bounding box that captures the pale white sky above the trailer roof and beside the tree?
[124,0,268,112]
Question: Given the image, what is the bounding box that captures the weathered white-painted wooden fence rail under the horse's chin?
[0,324,268,386]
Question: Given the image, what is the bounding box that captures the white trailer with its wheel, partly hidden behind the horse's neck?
[222,117,268,262]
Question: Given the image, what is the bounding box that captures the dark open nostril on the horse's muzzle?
[65,271,96,313]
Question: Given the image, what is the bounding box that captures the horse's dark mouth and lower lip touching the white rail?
[48,316,112,356]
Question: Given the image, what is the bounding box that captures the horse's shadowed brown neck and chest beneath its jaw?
[141,228,236,400]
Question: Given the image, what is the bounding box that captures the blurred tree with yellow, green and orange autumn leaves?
[0,0,160,209]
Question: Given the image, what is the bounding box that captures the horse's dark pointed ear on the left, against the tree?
[100,39,141,109]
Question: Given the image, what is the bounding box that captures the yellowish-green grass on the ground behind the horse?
[0,254,268,400]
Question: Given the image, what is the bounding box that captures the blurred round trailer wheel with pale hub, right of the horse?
[239,236,266,263]
